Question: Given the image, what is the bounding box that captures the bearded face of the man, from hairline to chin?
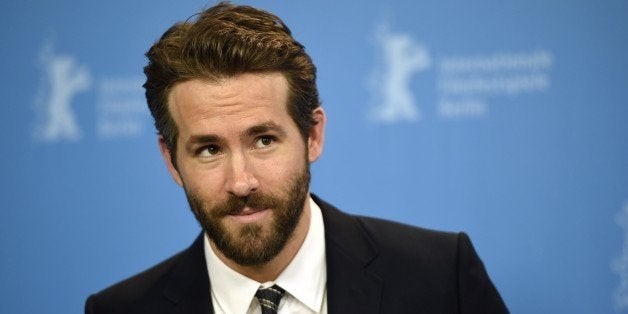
[160,73,324,266]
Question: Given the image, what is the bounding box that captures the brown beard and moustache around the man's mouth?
[184,161,310,266]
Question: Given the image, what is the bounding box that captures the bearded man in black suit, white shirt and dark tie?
[85,3,507,313]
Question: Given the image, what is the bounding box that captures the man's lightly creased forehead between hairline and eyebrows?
[168,72,290,135]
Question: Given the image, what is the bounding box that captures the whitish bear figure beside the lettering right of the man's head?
[371,25,431,123]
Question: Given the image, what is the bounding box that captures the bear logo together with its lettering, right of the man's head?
[369,21,554,123]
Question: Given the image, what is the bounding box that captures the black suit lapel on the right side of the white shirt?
[312,195,383,314]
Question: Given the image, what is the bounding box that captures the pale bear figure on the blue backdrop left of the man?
[35,44,92,142]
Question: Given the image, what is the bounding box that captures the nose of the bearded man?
[227,154,259,197]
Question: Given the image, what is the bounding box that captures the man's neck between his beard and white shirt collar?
[209,195,311,283]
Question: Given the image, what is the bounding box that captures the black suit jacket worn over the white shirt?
[85,196,508,314]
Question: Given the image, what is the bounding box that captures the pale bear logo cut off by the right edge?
[611,202,628,311]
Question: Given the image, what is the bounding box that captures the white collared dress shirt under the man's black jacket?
[204,198,327,314]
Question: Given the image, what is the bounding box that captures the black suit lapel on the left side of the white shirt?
[163,233,214,314]
